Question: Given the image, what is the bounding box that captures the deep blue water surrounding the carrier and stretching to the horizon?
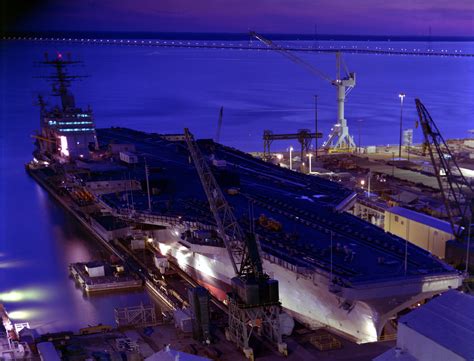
[0,38,474,331]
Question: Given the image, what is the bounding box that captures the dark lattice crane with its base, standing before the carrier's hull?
[184,128,287,360]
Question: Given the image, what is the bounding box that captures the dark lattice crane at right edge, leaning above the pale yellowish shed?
[415,99,474,243]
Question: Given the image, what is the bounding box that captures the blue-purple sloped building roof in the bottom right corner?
[399,290,474,360]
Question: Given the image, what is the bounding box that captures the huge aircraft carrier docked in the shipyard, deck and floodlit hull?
[29,54,462,342]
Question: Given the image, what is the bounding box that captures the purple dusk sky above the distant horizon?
[12,0,474,36]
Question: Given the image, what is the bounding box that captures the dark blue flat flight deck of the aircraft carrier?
[93,128,456,284]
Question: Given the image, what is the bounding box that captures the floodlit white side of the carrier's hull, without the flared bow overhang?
[158,235,377,342]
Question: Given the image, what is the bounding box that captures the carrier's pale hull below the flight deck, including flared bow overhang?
[157,231,460,343]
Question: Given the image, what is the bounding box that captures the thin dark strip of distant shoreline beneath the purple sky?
[0,31,474,42]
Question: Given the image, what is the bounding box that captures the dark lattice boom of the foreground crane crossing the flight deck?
[184,128,263,277]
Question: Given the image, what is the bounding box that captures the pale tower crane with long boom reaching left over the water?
[250,31,356,150]
